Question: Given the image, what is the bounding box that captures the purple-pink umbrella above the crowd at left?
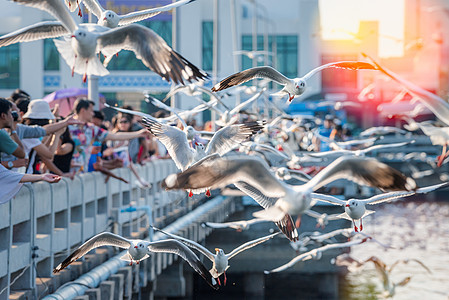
[43,88,106,117]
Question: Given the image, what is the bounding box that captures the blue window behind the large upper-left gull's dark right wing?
[108,21,172,71]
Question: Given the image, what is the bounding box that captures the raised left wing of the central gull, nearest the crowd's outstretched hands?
[142,118,195,171]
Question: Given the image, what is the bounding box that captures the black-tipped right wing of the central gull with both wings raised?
[206,121,265,156]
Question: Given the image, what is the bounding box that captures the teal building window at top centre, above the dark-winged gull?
[242,35,298,78]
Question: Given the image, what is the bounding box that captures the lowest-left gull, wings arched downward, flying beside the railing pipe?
[53,232,218,289]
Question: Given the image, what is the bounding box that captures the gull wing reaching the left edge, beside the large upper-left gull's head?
[0,21,69,47]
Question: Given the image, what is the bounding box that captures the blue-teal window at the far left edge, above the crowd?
[0,44,20,89]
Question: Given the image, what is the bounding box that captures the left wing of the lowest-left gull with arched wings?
[53,232,132,273]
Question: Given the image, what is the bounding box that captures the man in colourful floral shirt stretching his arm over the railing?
[68,98,148,172]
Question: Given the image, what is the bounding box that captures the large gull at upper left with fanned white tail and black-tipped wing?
[14,0,207,84]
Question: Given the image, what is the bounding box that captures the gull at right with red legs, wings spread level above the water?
[312,182,447,232]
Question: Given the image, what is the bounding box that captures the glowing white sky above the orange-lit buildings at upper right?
[319,0,405,57]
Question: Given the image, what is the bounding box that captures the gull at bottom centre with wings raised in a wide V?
[151,226,280,285]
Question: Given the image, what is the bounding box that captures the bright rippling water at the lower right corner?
[343,201,449,300]
